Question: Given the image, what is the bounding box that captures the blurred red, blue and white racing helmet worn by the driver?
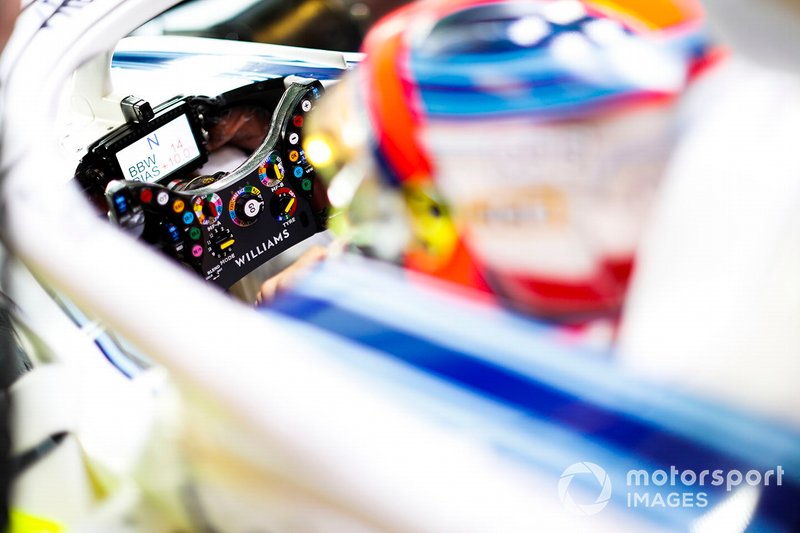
[306,0,715,321]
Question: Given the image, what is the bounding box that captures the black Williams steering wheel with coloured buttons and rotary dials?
[75,79,327,289]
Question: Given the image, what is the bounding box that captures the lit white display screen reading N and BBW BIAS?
[116,115,200,183]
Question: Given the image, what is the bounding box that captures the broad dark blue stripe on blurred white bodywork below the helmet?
[273,272,800,531]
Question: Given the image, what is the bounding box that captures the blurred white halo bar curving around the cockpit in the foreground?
[2,0,600,532]
